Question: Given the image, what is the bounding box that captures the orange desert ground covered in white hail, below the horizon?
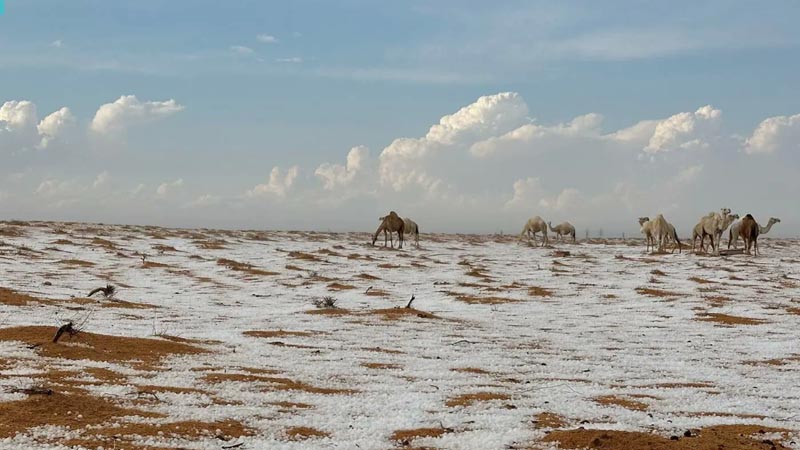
[0,222,800,450]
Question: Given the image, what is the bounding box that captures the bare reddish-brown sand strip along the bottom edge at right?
[544,425,789,450]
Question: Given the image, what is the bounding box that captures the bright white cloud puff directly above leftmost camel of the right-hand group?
[643,105,722,154]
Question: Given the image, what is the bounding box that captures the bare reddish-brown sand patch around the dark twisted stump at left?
[0,326,206,366]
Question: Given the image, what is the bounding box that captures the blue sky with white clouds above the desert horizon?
[0,0,800,236]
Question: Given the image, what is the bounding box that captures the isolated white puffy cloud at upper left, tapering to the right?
[89,95,184,136]
